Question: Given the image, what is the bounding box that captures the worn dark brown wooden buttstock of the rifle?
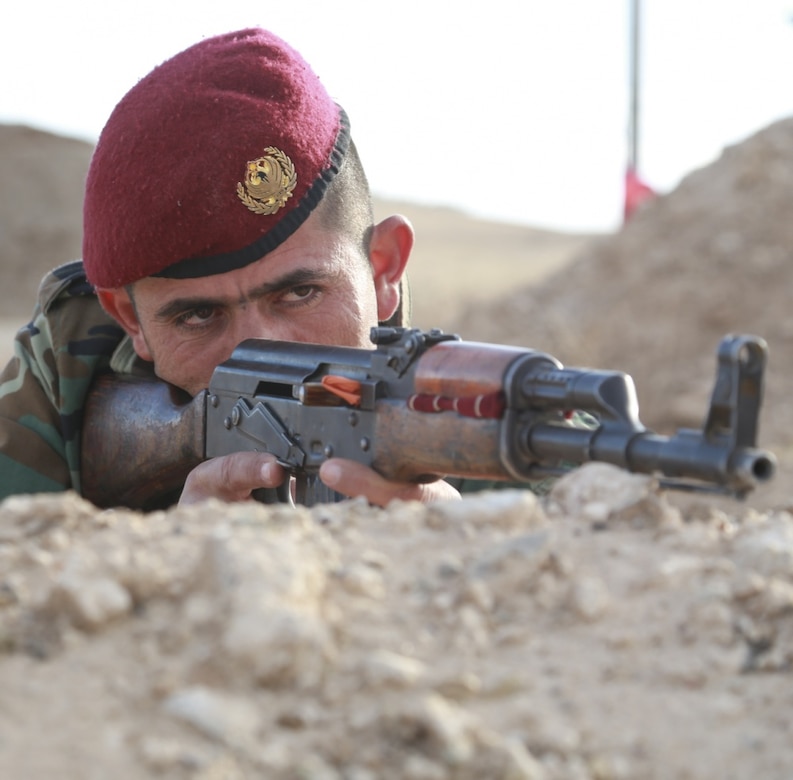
[81,374,206,509]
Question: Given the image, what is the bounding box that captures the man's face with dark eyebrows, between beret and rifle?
[108,213,388,394]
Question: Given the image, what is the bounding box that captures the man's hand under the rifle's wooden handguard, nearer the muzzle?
[319,458,460,506]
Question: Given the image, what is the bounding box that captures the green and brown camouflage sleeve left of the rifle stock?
[0,262,124,500]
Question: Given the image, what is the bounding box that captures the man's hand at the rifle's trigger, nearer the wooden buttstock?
[179,452,286,506]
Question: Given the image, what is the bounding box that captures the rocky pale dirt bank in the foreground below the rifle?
[0,464,793,780]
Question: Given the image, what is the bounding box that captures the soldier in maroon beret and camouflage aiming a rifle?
[0,29,458,505]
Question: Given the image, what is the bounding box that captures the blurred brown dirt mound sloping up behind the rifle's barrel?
[456,119,793,446]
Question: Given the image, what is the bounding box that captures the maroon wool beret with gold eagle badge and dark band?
[83,29,349,288]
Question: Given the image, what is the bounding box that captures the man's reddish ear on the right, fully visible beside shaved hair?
[369,215,414,322]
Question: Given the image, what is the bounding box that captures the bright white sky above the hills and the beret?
[0,0,793,232]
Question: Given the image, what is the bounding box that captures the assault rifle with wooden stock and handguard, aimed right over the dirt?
[82,327,775,508]
